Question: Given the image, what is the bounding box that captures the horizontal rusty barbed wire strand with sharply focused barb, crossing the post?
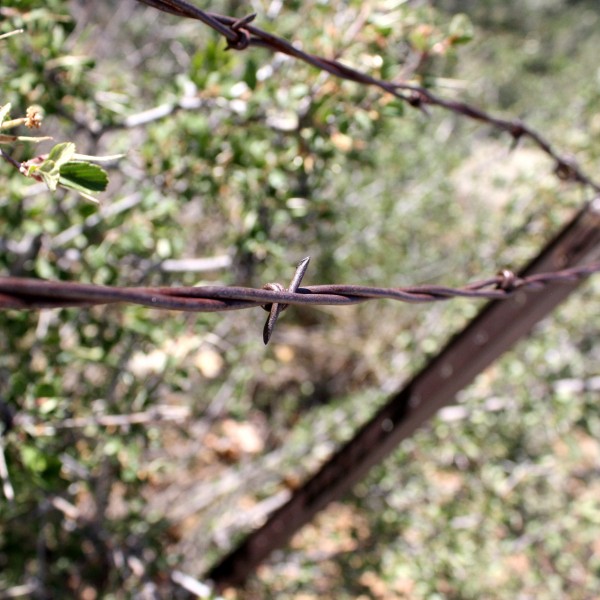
[0,257,600,344]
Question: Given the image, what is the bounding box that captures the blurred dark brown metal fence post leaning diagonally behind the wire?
[207,197,600,589]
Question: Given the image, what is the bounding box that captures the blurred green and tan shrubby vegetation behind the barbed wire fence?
[0,0,600,600]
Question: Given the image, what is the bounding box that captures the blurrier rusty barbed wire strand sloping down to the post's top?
[138,0,600,192]
